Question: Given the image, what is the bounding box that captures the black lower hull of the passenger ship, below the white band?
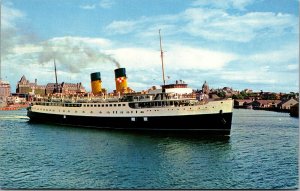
[27,111,232,134]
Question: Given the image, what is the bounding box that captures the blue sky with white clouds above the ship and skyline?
[1,0,299,93]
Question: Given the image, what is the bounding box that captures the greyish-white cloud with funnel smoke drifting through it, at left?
[3,36,118,77]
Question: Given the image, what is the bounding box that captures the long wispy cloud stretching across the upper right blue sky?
[105,5,298,43]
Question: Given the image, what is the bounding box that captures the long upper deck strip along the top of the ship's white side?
[32,93,207,109]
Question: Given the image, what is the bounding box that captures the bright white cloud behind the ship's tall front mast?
[108,44,237,71]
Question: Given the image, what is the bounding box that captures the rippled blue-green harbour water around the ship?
[0,110,299,189]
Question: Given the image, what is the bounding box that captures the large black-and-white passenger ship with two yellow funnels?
[27,31,233,135]
